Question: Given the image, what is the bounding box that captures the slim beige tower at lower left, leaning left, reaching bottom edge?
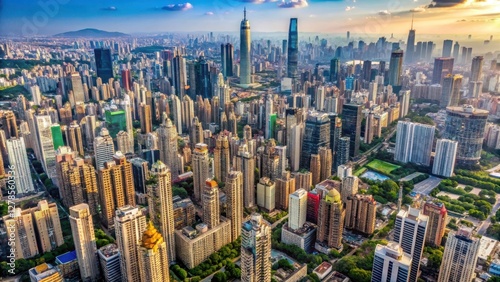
[69,204,100,282]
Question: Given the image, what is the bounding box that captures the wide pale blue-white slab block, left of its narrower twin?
[394,121,436,166]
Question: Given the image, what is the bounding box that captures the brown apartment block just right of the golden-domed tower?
[345,194,377,234]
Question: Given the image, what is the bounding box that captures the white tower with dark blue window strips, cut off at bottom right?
[372,242,411,282]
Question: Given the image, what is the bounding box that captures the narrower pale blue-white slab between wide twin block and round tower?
[432,139,458,177]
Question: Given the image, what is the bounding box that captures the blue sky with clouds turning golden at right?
[0,0,500,39]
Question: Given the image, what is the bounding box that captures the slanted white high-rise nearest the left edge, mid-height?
[7,137,35,194]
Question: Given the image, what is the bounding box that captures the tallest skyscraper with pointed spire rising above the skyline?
[240,8,252,85]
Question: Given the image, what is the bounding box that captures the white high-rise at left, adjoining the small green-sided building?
[35,115,57,179]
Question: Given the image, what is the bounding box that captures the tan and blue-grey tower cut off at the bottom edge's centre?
[240,213,271,282]
